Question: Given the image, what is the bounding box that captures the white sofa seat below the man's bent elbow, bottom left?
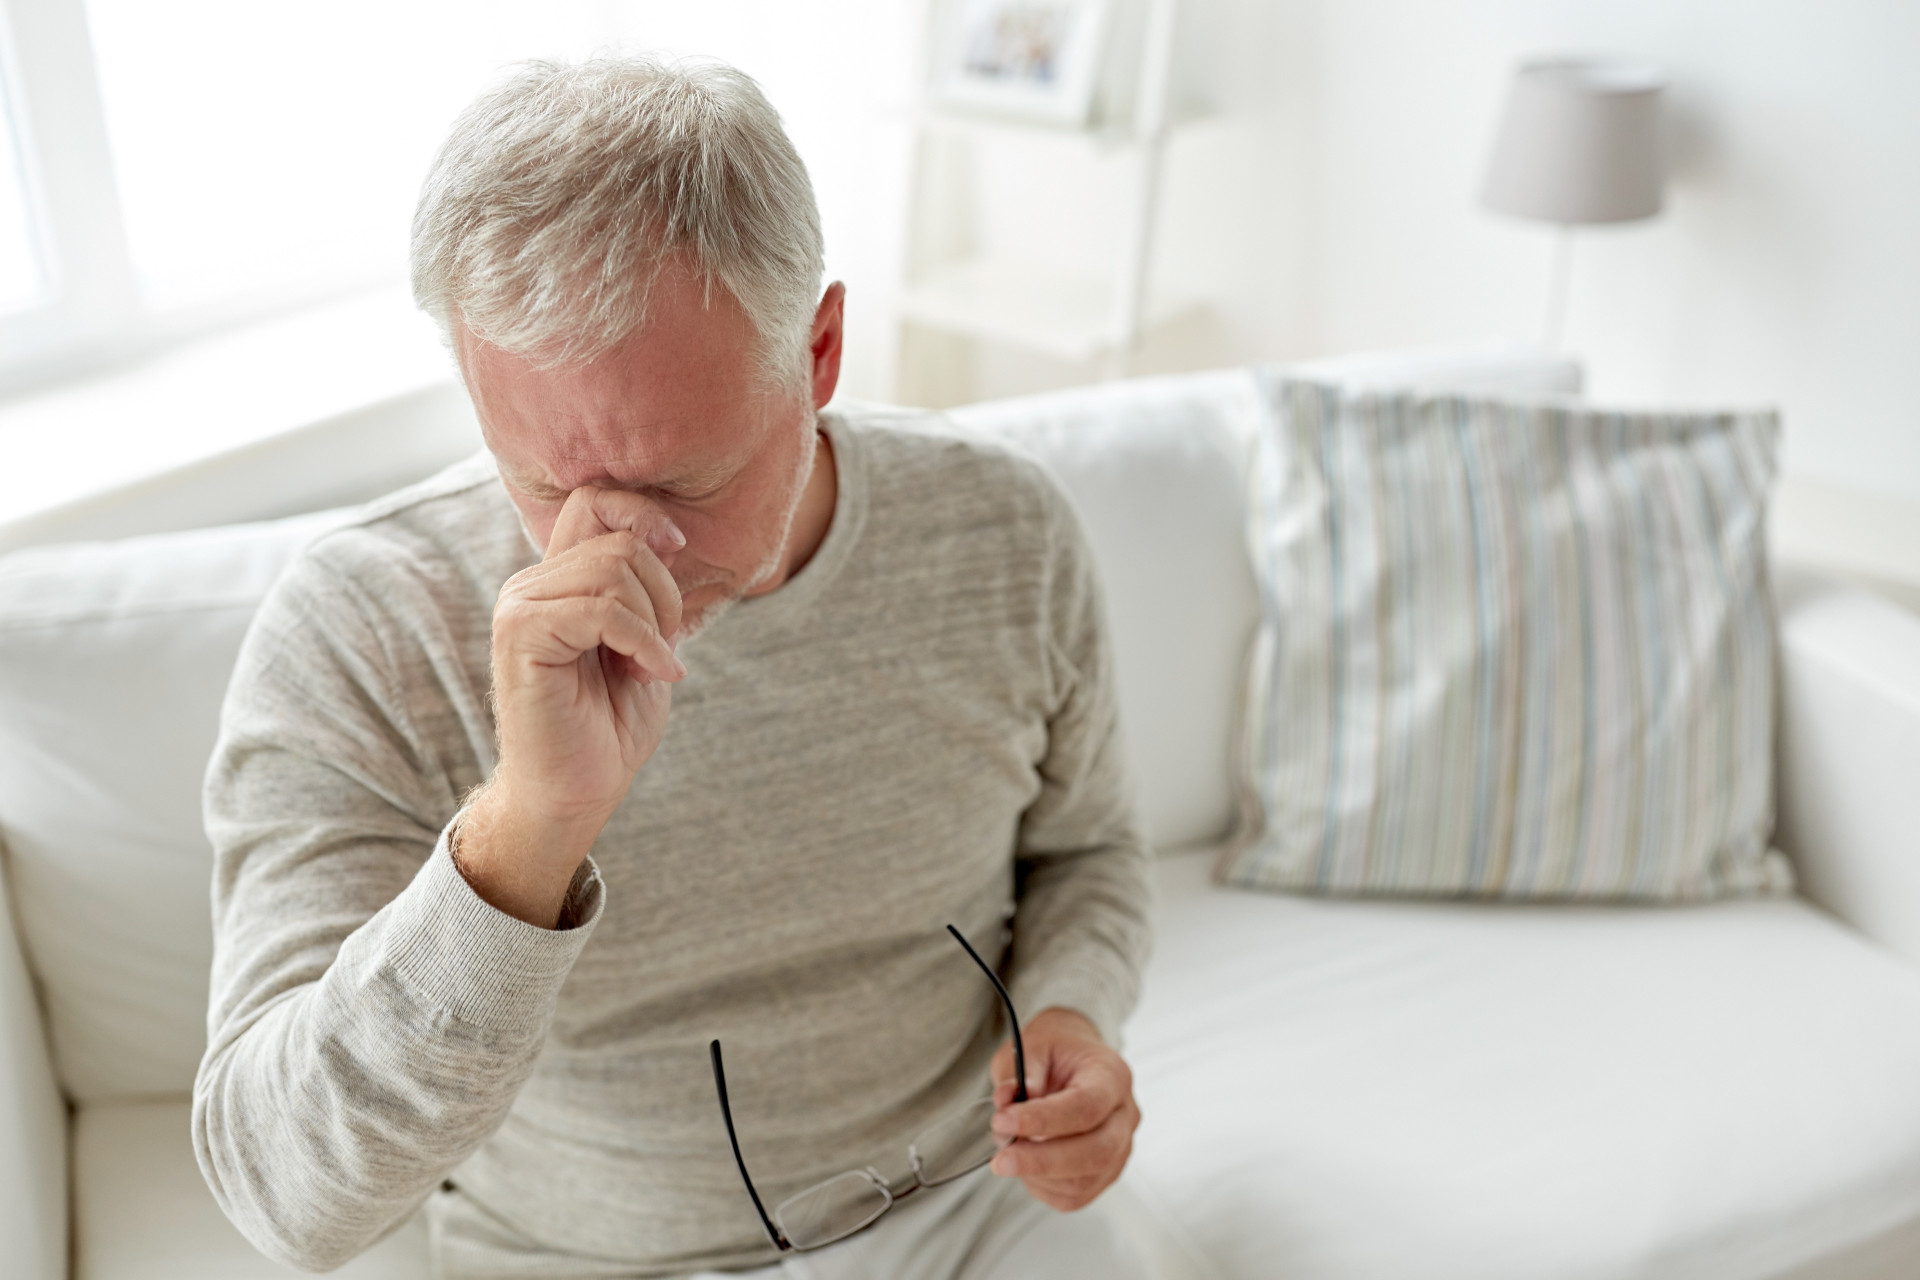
[73,1098,428,1280]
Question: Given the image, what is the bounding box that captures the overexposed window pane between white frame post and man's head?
[82,0,599,311]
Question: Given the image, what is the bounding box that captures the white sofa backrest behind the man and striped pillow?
[0,351,1578,1103]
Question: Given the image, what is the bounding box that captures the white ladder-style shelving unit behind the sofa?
[899,0,1196,401]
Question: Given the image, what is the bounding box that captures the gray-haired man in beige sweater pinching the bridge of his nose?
[194,59,1146,1280]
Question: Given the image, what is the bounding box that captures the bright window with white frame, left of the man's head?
[0,0,603,391]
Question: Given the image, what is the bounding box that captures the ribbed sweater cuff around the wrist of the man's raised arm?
[388,831,607,1034]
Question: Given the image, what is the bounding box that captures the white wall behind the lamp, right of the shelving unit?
[925,0,1920,603]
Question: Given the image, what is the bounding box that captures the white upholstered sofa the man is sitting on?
[0,351,1920,1280]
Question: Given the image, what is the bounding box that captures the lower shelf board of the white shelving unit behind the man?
[900,257,1194,361]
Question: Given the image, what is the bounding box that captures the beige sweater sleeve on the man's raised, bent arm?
[192,553,603,1270]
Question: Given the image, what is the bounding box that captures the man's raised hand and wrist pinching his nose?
[457,486,687,929]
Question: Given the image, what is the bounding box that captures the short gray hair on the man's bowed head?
[413,58,824,390]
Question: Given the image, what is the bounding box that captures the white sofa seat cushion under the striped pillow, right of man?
[1127,850,1920,1280]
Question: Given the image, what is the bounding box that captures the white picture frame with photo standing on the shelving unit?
[929,0,1112,129]
